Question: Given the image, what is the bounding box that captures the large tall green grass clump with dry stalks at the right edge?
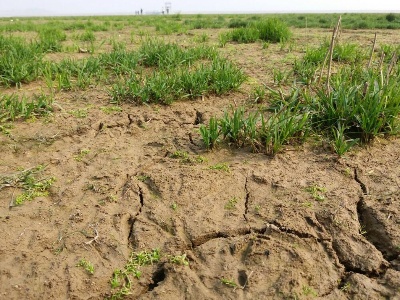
[294,22,400,156]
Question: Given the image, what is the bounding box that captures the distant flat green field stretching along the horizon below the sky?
[0,13,400,34]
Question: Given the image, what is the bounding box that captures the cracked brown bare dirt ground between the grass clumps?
[0,30,400,299]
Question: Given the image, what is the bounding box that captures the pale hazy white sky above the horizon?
[0,0,400,16]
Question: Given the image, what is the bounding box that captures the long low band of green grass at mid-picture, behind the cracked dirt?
[110,58,246,104]
